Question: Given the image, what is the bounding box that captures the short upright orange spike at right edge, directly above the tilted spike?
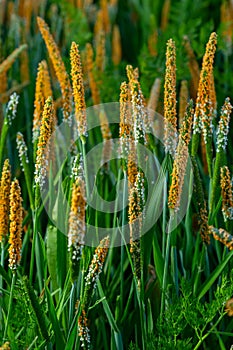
[220,166,233,221]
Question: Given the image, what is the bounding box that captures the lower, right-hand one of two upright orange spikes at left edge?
[9,180,23,270]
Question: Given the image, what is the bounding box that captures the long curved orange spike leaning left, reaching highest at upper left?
[37,17,72,122]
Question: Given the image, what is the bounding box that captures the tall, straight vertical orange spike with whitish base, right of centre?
[164,39,177,155]
